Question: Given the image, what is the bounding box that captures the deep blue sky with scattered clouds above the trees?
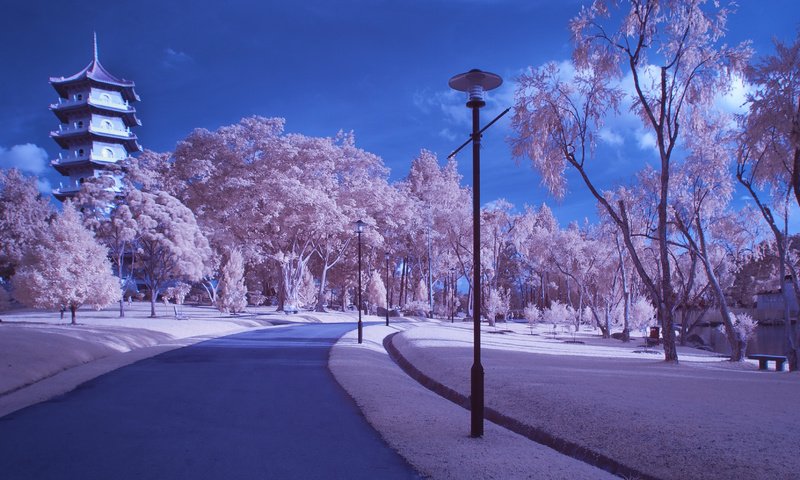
[0,0,800,224]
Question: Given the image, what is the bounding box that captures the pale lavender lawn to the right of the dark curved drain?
[394,323,800,479]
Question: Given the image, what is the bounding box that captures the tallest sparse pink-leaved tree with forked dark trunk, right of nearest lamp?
[512,0,749,362]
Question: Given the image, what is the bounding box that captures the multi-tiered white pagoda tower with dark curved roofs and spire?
[50,34,142,201]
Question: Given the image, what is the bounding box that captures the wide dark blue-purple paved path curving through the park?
[0,324,417,480]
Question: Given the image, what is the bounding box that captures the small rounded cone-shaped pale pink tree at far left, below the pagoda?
[12,202,121,325]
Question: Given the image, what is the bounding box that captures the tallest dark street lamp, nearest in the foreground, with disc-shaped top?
[449,69,508,437]
